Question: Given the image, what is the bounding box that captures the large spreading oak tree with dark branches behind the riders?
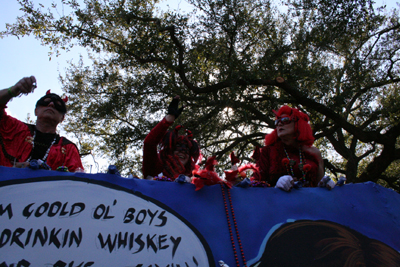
[1,0,400,191]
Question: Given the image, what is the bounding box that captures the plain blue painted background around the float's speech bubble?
[0,167,400,267]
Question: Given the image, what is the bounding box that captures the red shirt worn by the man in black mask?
[0,105,83,172]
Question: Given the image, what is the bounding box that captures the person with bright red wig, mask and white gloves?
[253,106,324,191]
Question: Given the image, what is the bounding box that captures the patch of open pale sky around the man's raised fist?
[0,0,77,121]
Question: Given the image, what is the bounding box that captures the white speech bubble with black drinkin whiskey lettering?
[0,180,214,267]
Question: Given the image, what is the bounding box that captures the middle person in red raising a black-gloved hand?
[142,96,200,180]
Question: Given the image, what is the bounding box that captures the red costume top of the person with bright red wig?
[253,141,318,187]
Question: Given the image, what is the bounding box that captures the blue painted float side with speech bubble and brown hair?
[0,167,400,267]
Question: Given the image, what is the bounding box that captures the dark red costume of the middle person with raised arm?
[142,118,200,180]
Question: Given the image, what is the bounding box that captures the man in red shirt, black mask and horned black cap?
[0,76,83,172]
